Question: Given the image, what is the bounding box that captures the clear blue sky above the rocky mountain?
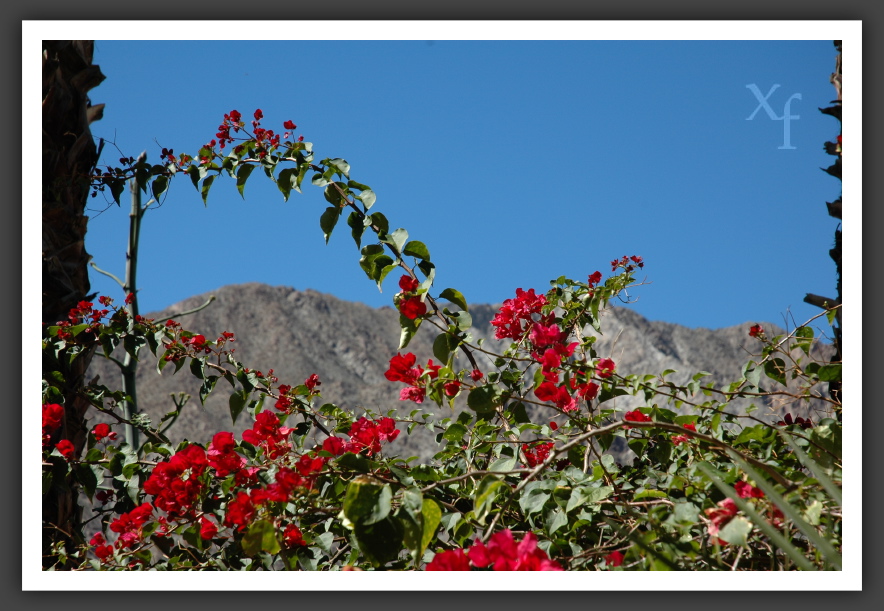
[87,39,841,328]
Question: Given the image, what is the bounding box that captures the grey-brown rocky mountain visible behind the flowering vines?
[87,283,831,460]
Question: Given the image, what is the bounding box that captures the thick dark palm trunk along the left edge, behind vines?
[42,40,104,568]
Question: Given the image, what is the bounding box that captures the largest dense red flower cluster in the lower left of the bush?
[144,444,209,516]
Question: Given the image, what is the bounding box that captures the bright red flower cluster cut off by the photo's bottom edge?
[426,529,563,571]
